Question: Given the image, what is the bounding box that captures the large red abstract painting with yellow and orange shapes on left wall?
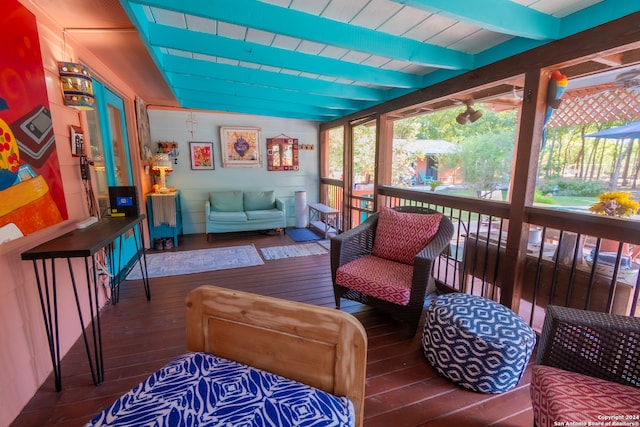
[0,0,68,244]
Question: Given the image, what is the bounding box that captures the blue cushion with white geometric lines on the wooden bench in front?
[87,353,355,427]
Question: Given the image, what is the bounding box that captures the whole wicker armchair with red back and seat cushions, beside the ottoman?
[331,206,454,336]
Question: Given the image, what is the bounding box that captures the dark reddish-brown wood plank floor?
[12,233,533,427]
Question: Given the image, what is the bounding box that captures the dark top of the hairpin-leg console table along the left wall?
[21,214,145,260]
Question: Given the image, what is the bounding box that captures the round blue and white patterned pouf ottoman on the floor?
[422,293,536,393]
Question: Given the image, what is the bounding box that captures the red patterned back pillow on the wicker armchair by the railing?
[371,207,442,264]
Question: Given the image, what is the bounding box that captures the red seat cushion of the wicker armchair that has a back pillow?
[336,255,413,305]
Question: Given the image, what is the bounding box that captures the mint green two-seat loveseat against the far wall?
[205,191,287,236]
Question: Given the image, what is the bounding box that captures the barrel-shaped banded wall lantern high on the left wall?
[58,62,96,110]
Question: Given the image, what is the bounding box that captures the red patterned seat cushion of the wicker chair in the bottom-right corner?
[531,365,640,427]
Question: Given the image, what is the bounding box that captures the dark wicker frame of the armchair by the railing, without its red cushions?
[331,206,454,336]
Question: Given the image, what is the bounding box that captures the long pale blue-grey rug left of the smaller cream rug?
[126,245,264,280]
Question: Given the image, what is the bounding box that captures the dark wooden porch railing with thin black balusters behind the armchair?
[323,183,640,330]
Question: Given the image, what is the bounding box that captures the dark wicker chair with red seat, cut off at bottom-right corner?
[530,305,640,427]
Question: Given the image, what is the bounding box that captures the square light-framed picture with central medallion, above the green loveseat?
[220,126,262,168]
